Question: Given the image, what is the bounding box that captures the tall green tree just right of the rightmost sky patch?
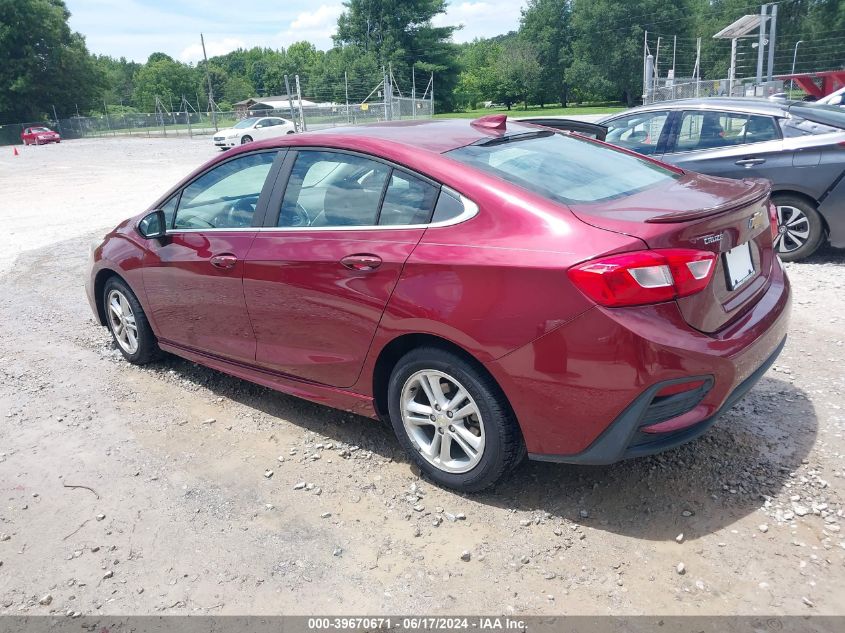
[519,0,572,106]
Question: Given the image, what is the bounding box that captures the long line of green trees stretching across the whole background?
[0,0,845,122]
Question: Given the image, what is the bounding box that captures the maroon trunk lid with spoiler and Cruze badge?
[568,172,774,334]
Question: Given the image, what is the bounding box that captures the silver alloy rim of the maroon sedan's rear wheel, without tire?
[401,370,484,473]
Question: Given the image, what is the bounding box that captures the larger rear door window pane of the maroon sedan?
[278,151,390,227]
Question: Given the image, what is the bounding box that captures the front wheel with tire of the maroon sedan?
[102,277,158,365]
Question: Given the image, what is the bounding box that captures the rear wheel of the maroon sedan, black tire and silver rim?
[388,347,525,492]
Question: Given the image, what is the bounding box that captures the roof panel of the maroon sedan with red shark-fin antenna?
[296,119,537,154]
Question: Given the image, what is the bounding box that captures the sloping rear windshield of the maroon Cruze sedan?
[446,131,679,203]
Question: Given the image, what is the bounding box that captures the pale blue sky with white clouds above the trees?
[65,0,524,62]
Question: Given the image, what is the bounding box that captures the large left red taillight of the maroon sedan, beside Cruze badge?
[568,248,716,308]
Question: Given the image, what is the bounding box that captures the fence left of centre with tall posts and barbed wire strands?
[0,70,434,145]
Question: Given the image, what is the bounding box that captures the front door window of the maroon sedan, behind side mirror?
[173,152,276,229]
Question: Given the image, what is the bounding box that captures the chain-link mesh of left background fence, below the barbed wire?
[0,97,433,145]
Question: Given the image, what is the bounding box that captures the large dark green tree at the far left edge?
[0,0,104,121]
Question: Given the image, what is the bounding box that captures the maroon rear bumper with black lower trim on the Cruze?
[486,262,791,464]
